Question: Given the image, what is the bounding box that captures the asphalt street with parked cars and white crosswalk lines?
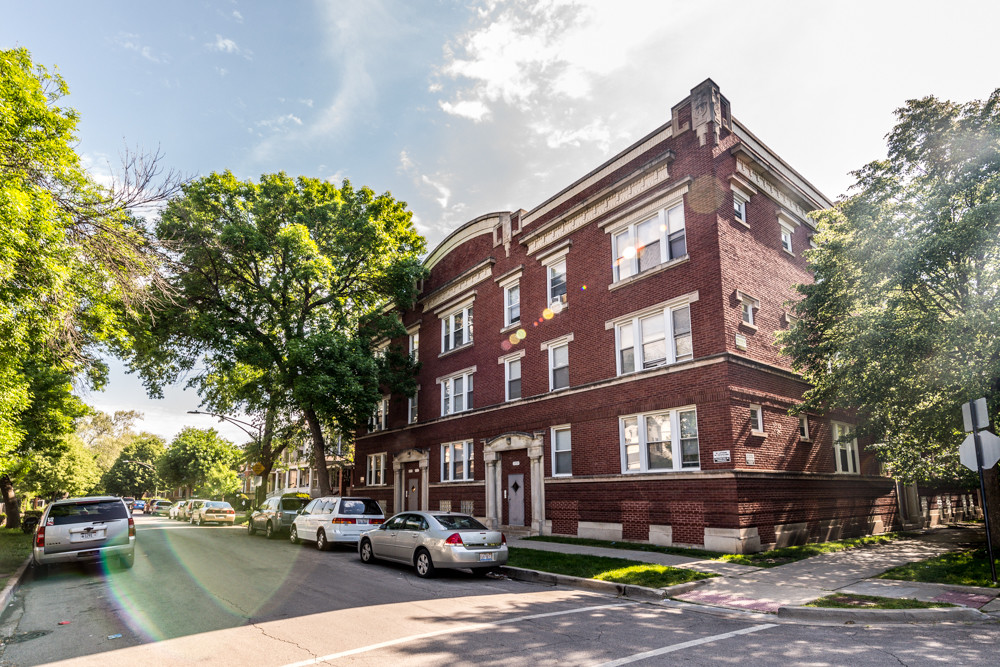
[0,515,1000,667]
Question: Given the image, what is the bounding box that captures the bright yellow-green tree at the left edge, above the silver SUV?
[0,49,177,525]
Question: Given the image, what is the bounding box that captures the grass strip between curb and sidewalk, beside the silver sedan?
[507,548,714,588]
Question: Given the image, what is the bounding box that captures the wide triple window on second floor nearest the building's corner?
[616,304,694,375]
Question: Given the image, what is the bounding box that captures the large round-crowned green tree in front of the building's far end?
[132,172,425,494]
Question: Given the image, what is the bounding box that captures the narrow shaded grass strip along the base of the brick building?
[526,533,900,567]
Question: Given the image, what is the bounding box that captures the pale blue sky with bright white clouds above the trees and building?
[0,0,1000,443]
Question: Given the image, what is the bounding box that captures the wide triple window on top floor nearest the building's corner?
[612,202,687,282]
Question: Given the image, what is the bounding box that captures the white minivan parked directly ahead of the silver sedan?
[289,496,385,551]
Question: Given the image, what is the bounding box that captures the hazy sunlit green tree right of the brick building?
[785,90,1000,544]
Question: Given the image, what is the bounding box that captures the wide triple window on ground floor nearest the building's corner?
[619,409,700,473]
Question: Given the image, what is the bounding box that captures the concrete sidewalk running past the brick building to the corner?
[508,528,1000,617]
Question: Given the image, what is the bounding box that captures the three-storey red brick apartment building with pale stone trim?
[352,80,898,553]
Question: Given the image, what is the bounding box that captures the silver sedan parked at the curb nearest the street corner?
[358,512,507,577]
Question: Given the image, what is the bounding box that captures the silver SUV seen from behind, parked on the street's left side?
[31,496,135,572]
